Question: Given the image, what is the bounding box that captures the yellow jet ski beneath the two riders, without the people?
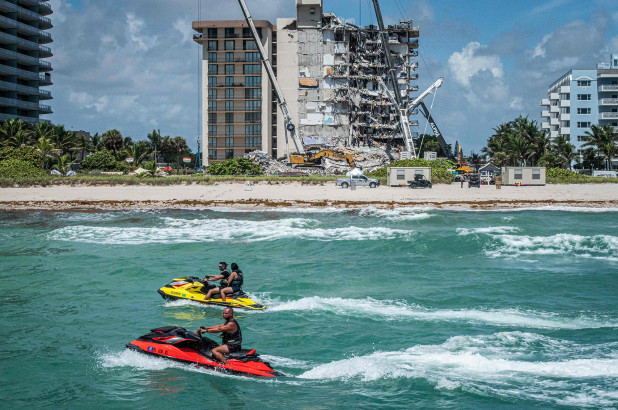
[158,276,266,310]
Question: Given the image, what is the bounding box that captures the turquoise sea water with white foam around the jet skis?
[0,208,618,409]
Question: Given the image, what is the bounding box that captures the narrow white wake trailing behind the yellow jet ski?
[264,296,618,329]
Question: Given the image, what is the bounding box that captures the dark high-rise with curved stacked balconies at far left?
[0,0,52,123]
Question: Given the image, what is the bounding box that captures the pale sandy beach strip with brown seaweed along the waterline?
[0,182,618,210]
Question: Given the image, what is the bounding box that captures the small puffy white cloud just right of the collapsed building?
[448,42,504,87]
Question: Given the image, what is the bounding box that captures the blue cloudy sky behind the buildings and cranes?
[44,0,618,154]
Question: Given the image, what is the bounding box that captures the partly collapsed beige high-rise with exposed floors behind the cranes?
[193,0,419,167]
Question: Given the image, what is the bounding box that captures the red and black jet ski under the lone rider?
[127,326,284,377]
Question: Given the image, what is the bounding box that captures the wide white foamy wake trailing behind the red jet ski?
[298,332,618,406]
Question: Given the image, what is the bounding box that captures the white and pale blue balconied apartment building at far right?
[541,54,618,156]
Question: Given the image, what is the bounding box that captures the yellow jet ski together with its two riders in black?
[158,262,266,310]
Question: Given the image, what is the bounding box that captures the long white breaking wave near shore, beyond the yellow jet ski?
[48,218,414,245]
